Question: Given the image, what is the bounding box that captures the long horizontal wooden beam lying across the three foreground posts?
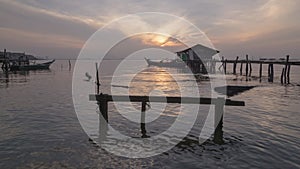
[89,94,245,106]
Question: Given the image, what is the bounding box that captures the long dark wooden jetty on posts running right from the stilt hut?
[216,55,300,84]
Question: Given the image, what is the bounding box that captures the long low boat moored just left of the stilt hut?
[145,58,186,68]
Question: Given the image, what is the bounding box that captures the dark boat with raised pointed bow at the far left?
[10,60,55,71]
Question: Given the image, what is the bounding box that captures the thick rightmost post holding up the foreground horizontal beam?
[213,98,225,144]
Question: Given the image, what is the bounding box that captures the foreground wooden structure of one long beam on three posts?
[89,93,245,144]
